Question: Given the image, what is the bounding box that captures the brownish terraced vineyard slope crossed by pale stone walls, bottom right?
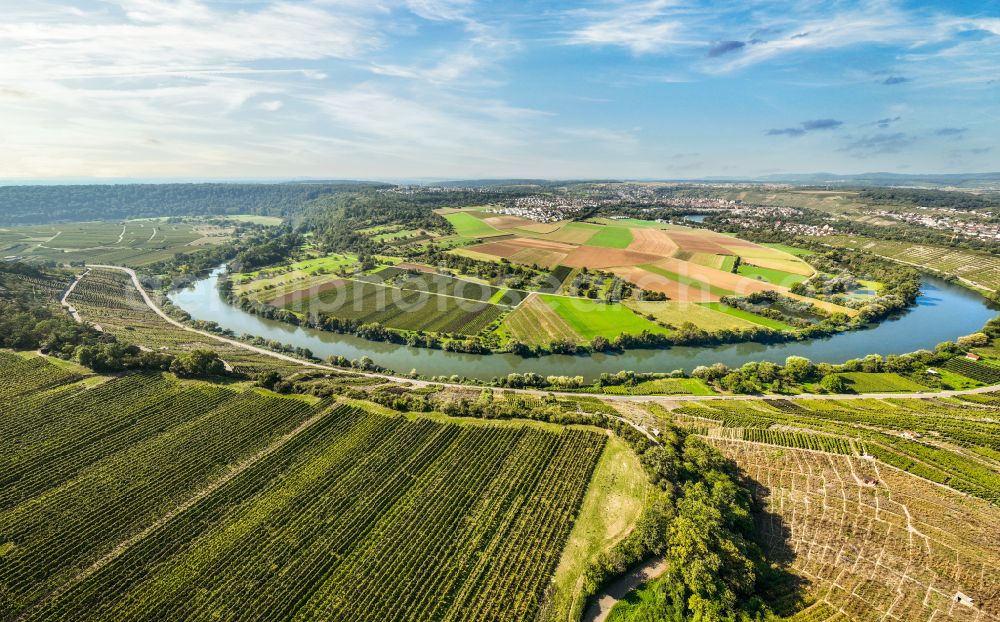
[710,439,1000,622]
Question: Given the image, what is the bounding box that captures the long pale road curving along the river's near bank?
[87,264,1000,402]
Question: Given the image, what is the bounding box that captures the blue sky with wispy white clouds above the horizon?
[0,0,1000,180]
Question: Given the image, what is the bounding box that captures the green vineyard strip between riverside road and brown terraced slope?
[652,398,1000,503]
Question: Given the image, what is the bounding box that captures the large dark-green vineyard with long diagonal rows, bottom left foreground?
[0,352,605,620]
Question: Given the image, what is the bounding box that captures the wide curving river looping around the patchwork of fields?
[170,272,996,382]
